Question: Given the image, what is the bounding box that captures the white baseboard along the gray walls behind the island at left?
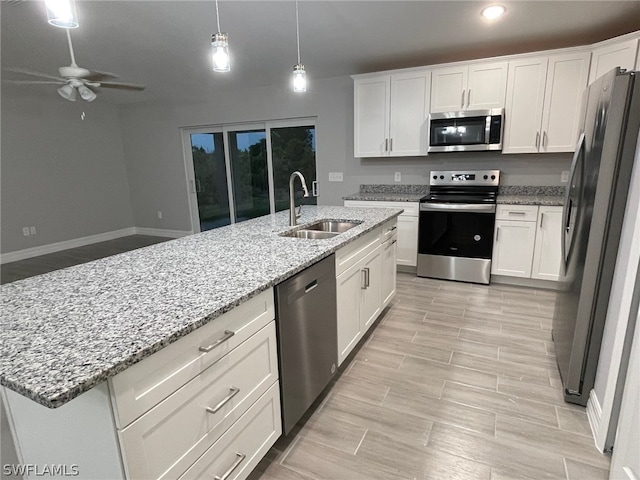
[0,227,193,264]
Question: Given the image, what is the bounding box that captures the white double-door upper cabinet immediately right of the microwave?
[502,52,590,153]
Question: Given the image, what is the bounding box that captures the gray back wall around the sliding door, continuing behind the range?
[121,73,571,230]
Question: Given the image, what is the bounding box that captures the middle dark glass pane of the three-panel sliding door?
[229,130,270,222]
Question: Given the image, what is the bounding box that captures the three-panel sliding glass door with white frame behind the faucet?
[183,119,317,231]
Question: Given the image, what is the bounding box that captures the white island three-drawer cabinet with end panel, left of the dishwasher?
[6,290,282,480]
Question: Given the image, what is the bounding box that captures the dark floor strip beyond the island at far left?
[0,235,171,284]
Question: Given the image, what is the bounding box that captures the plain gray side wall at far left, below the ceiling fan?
[1,89,133,253]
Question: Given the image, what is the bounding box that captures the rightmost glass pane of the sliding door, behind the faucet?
[271,126,318,211]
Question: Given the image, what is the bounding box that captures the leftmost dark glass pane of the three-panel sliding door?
[191,133,231,231]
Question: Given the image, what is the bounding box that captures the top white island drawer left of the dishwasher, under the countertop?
[109,290,275,428]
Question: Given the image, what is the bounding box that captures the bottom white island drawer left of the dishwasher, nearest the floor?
[180,382,282,480]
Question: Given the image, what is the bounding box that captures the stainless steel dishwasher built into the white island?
[276,255,338,435]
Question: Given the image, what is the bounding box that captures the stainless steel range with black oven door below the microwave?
[418,170,500,284]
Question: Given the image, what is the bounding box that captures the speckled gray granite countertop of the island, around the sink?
[0,206,402,408]
